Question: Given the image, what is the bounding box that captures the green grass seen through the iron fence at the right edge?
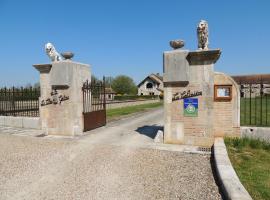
[240,97,270,126]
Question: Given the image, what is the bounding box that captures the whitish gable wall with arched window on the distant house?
[138,78,163,95]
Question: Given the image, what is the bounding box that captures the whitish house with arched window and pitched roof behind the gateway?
[137,73,163,95]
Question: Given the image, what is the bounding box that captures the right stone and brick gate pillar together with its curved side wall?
[164,49,240,147]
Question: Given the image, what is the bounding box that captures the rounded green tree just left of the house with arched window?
[112,75,137,95]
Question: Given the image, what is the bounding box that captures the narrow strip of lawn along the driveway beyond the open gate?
[106,102,163,121]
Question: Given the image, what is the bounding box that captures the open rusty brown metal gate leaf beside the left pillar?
[82,78,106,131]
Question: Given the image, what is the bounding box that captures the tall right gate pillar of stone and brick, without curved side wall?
[164,50,221,146]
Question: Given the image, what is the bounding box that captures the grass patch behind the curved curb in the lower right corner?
[225,138,270,200]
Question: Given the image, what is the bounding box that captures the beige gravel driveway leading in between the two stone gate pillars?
[0,109,221,200]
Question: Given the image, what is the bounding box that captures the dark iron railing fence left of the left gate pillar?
[0,87,40,117]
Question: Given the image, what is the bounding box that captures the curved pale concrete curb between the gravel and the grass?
[214,138,252,200]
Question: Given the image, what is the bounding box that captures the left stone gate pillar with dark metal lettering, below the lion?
[34,60,91,136]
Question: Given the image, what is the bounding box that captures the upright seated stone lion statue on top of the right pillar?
[197,20,209,50]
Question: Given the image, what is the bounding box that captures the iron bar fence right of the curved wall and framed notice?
[239,78,270,126]
